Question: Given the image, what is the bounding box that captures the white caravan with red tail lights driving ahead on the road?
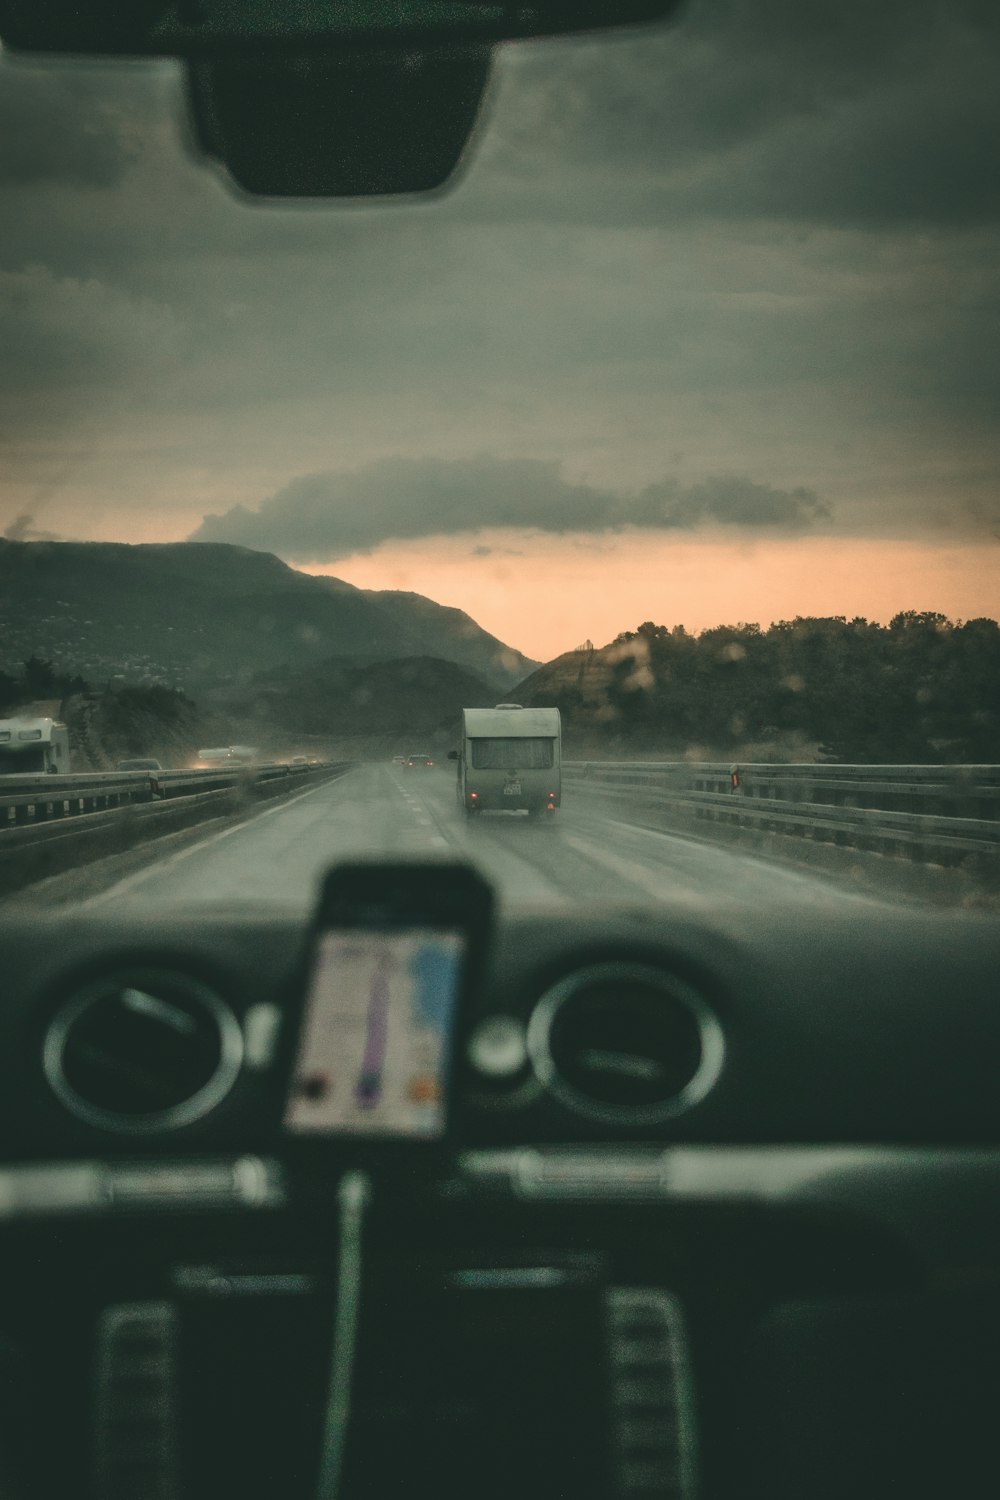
[451,704,562,818]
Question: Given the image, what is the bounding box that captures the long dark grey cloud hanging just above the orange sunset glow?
[189,455,829,561]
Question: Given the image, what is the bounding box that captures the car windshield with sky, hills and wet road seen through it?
[0,0,1000,911]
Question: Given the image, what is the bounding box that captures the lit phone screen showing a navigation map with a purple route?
[285,927,468,1140]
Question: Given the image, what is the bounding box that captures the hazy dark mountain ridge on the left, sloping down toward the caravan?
[0,540,537,692]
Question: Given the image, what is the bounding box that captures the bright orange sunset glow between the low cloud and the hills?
[303,534,1000,660]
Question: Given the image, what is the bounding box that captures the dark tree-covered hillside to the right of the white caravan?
[516,611,1000,764]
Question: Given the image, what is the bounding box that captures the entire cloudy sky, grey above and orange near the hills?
[0,0,1000,657]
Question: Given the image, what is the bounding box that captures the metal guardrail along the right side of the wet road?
[562,761,1000,863]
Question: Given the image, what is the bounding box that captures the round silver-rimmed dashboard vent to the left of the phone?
[43,969,243,1134]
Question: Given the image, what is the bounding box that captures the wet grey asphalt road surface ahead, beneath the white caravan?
[87,765,861,912]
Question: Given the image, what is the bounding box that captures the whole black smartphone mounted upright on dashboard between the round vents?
[283,863,493,1146]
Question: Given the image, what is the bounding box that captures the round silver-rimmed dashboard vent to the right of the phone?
[528,963,724,1125]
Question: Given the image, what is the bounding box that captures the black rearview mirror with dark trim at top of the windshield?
[0,0,679,198]
